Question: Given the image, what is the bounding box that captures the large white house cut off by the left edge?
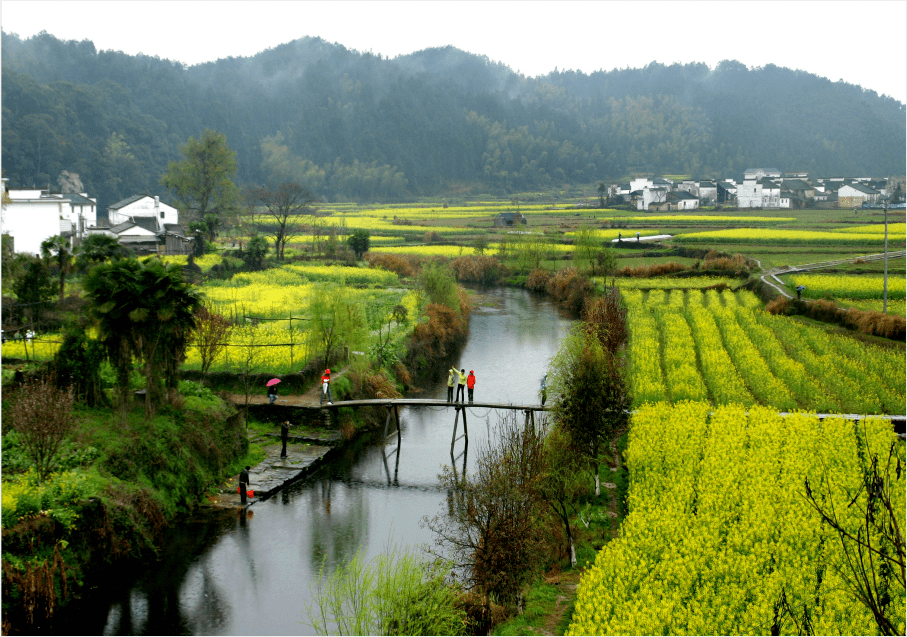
[0,179,97,254]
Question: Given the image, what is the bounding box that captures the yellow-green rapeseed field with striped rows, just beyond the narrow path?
[623,289,907,414]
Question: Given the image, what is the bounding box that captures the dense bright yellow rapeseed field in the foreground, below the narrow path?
[566,402,905,635]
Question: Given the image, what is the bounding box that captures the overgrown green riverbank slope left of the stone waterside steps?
[2,383,259,634]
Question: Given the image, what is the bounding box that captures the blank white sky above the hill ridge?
[0,0,907,103]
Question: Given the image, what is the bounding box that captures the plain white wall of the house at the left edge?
[0,190,72,254]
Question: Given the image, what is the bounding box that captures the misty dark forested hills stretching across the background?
[2,33,907,209]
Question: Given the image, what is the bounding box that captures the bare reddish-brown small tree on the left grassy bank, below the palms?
[9,377,75,481]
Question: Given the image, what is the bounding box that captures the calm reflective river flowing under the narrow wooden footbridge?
[55,289,572,635]
